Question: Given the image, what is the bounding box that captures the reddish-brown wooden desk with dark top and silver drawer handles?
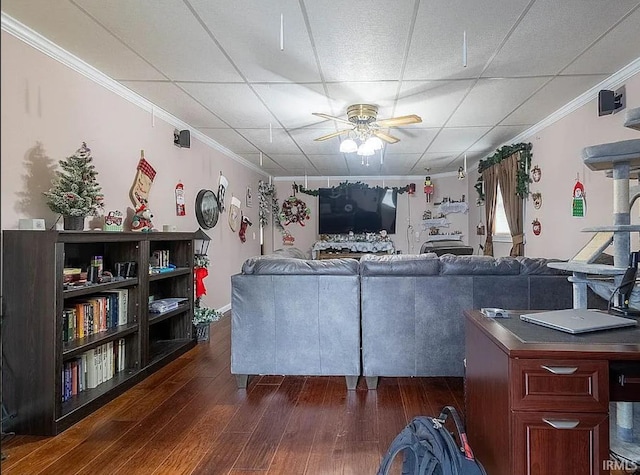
[464,310,640,475]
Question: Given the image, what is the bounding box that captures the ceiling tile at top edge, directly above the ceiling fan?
[304,0,413,81]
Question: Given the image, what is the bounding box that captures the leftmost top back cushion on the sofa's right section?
[360,253,440,275]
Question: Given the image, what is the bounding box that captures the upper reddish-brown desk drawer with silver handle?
[510,359,609,412]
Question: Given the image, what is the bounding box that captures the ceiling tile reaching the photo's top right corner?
[483,0,638,77]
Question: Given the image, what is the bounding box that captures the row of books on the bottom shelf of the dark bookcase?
[62,338,126,402]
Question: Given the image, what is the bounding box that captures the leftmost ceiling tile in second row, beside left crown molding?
[122,81,225,128]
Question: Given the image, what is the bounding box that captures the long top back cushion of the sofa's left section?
[242,256,358,275]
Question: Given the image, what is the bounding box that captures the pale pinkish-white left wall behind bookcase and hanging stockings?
[1,32,262,308]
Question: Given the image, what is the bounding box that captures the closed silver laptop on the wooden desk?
[520,308,638,334]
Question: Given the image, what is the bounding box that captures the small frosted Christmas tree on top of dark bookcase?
[44,142,103,217]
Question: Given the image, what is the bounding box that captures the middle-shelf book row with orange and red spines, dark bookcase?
[62,289,129,342]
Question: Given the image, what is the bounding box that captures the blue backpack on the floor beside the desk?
[378,406,487,475]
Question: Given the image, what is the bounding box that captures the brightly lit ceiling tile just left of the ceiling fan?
[253,84,329,128]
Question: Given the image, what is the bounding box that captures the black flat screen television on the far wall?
[318,186,398,234]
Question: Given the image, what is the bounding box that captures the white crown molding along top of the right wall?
[508,58,640,144]
